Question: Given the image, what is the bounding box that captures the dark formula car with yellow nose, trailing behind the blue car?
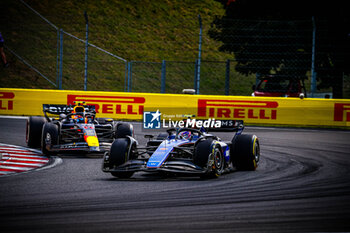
[26,104,133,155]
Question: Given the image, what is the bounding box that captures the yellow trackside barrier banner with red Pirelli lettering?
[0,88,350,129]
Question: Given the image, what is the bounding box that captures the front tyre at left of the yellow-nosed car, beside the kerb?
[41,122,58,156]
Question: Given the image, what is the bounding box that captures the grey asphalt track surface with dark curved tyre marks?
[0,118,350,233]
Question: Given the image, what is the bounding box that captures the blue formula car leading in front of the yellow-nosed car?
[102,121,260,178]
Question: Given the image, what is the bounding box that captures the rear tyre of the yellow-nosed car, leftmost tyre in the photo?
[26,116,46,148]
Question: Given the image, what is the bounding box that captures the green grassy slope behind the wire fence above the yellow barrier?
[0,0,253,95]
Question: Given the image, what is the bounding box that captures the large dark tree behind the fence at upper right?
[209,0,350,98]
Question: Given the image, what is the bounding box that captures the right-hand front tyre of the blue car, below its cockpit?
[193,139,225,179]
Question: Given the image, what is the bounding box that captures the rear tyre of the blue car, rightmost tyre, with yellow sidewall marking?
[231,134,260,171]
